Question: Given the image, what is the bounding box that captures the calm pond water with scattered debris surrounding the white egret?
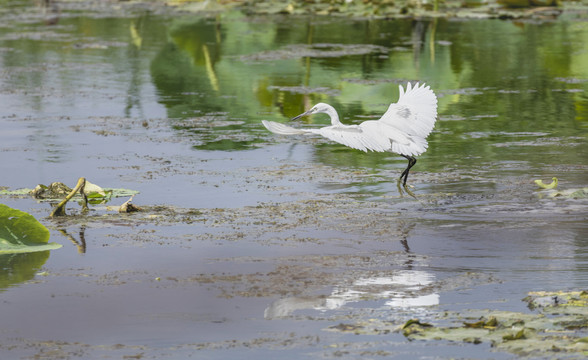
[0,2,588,359]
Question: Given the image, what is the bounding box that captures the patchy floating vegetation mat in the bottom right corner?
[327,291,588,359]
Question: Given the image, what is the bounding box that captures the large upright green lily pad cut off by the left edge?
[0,204,61,254]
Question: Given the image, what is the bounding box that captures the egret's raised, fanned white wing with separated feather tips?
[379,83,437,139]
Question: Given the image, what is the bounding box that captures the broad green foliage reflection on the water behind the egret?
[152,14,588,171]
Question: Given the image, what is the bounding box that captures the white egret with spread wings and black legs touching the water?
[261,83,437,189]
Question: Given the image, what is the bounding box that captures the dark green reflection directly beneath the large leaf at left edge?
[0,251,49,291]
